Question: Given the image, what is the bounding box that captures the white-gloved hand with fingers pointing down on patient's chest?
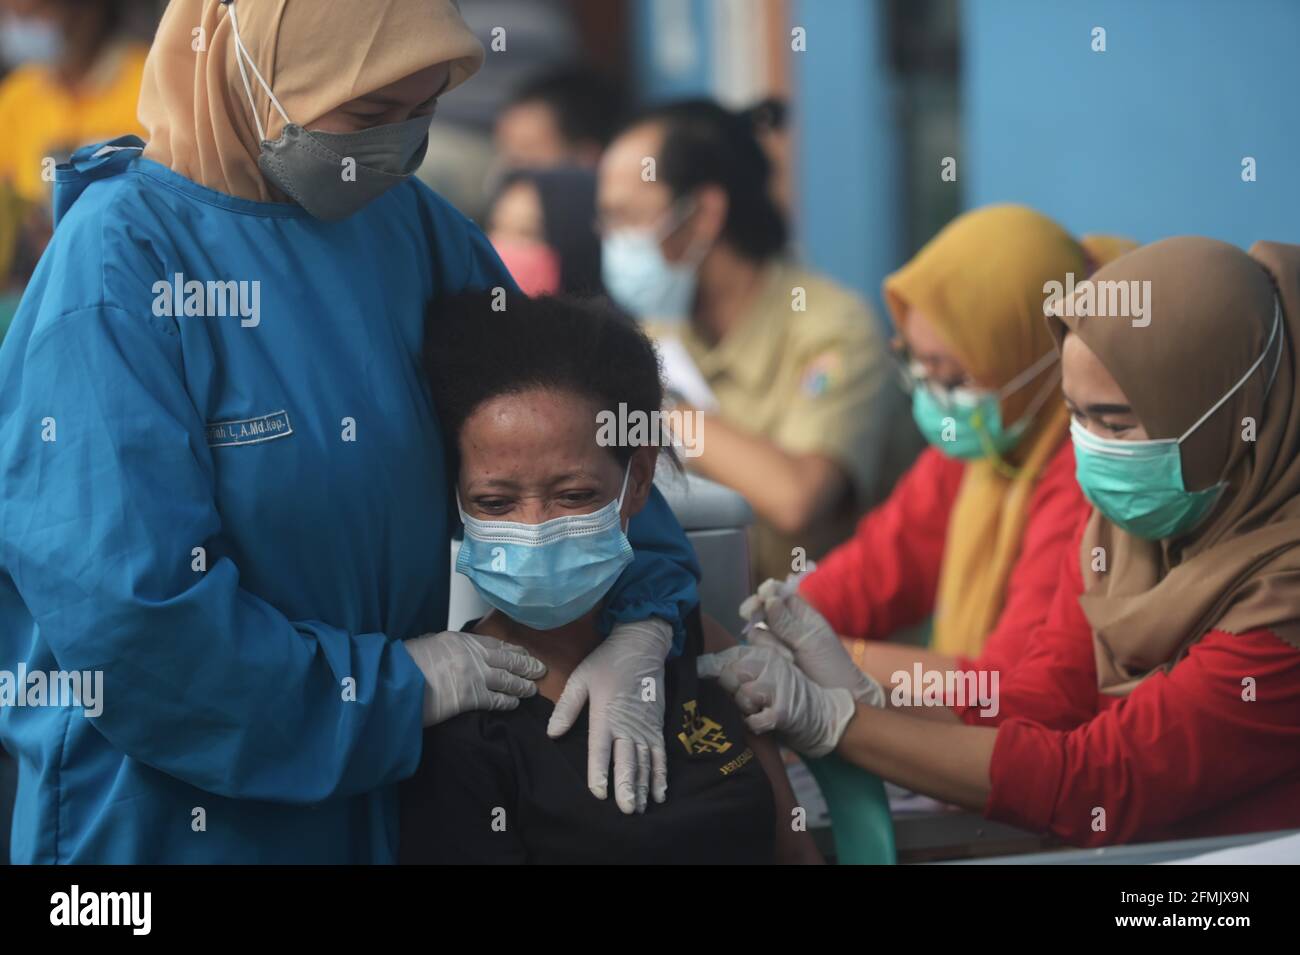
[546,617,672,813]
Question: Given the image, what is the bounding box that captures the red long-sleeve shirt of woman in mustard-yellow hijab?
[800,442,1088,670]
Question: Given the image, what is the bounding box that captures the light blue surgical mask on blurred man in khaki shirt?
[601,205,703,322]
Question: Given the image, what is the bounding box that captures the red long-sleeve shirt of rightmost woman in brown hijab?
[972,525,1300,846]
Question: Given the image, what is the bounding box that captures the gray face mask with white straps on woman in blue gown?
[228,3,433,222]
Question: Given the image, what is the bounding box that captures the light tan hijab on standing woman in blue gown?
[139,0,484,201]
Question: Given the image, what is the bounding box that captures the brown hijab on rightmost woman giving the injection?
[1048,238,1300,695]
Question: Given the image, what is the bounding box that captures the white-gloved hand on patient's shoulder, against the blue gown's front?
[403,630,546,726]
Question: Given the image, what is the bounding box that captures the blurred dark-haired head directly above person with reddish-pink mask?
[495,66,623,170]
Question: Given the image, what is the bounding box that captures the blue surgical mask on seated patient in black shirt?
[456,466,632,630]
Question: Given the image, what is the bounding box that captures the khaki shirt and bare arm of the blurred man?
[660,261,906,579]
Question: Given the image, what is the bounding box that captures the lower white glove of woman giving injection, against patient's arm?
[696,647,855,756]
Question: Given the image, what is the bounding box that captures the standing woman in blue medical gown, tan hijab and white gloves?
[0,0,698,863]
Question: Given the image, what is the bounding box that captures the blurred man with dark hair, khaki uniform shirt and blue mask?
[597,100,915,579]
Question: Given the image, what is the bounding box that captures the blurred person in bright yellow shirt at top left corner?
[0,0,148,298]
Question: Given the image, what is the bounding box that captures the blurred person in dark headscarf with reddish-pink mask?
[488,166,602,295]
